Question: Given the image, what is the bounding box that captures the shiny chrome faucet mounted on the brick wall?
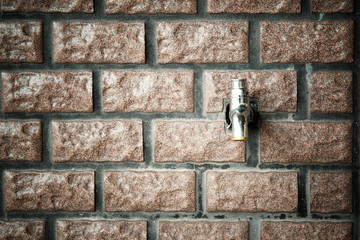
[228,79,254,141]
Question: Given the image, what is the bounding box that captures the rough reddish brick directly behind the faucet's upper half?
[204,71,297,112]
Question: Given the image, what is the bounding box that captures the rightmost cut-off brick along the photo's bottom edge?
[261,222,352,240]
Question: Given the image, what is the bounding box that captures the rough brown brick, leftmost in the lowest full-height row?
[4,171,95,212]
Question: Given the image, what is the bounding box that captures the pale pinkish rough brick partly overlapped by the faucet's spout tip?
[154,120,245,163]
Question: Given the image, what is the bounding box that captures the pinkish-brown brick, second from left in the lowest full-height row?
[104,171,196,212]
